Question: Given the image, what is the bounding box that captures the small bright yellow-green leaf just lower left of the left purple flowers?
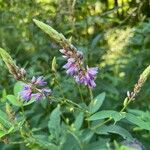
[7,95,23,107]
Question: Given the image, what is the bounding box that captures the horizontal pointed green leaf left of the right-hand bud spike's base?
[87,110,125,122]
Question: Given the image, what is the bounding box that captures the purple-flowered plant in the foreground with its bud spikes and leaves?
[0,19,150,150]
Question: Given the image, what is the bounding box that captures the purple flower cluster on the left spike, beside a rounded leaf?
[20,76,51,101]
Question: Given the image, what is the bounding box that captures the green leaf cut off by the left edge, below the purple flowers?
[0,110,12,128]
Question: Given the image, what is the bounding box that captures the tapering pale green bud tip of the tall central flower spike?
[33,19,76,51]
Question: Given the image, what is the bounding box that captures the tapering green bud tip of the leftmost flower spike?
[0,48,20,79]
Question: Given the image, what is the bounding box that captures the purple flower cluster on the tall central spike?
[60,49,98,88]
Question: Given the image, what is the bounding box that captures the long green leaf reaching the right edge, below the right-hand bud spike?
[125,113,150,130]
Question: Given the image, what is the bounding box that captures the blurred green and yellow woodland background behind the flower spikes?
[0,0,150,149]
